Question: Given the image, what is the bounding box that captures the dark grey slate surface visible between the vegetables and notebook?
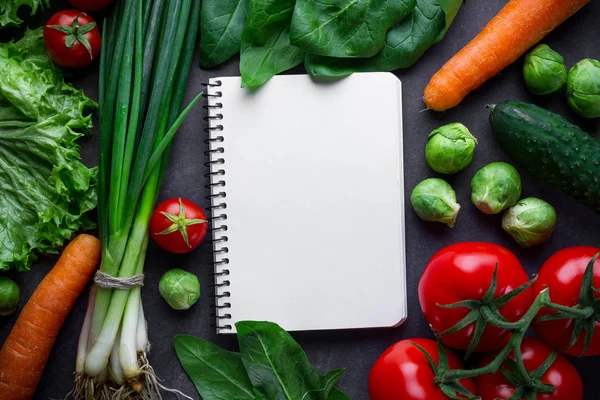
[0,0,600,400]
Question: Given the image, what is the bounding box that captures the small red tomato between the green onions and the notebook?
[150,198,208,254]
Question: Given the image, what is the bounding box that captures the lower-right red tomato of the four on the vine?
[475,338,583,400]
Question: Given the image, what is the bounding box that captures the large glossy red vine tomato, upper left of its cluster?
[419,242,533,352]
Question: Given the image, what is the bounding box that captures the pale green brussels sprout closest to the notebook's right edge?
[410,178,460,228]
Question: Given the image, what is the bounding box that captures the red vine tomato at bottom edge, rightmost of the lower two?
[476,338,583,400]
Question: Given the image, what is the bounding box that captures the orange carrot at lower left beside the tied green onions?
[0,235,100,400]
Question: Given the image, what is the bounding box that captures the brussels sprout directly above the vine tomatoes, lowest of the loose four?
[502,197,556,247]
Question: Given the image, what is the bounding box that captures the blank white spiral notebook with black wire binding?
[206,73,407,333]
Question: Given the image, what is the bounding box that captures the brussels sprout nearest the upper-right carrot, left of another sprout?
[523,44,567,95]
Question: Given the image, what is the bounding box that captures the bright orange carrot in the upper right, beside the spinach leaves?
[424,0,590,111]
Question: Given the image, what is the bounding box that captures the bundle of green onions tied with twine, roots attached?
[74,0,201,399]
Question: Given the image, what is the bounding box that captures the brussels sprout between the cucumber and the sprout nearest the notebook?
[471,162,522,214]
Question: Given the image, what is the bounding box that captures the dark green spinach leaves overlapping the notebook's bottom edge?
[174,321,349,400]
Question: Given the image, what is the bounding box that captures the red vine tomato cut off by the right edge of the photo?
[533,246,600,356]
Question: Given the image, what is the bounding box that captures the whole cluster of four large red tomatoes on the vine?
[369,243,600,400]
